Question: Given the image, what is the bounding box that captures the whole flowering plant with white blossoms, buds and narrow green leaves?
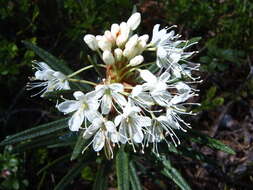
[1,12,234,190]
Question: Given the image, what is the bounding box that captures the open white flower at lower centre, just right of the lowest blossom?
[115,103,151,144]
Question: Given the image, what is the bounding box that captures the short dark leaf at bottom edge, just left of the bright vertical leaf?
[92,164,107,190]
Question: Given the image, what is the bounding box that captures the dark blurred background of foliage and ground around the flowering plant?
[0,0,253,190]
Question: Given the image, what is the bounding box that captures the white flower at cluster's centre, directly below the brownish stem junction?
[94,83,127,114]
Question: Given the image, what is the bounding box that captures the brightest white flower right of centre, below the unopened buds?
[139,70,171,106]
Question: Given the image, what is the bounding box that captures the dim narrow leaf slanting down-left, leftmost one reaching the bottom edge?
[54,159,87,190]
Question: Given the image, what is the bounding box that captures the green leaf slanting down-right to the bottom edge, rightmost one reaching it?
[157,156,191,190]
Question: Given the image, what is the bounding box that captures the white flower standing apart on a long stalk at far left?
[27,62,70,97]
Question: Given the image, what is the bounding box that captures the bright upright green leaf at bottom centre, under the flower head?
[116,146,129,190]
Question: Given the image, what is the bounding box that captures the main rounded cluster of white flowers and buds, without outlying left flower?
[28,13,199,159]
